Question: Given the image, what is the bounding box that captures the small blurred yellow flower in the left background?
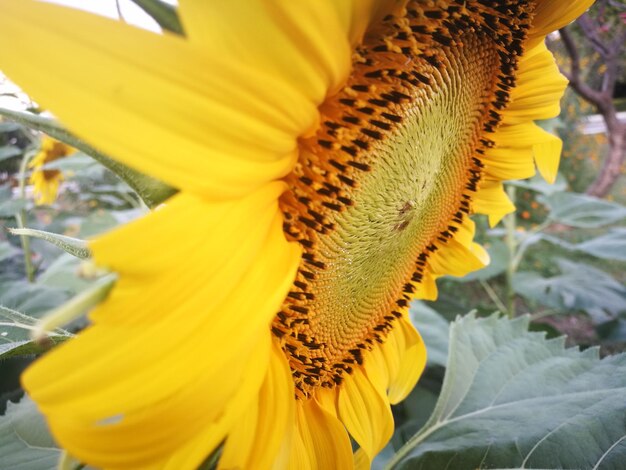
[28,135,75,205]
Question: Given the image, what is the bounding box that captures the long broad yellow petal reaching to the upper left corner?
[0,0,322,199]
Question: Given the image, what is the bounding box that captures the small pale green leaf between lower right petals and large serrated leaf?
[409,301,450,367]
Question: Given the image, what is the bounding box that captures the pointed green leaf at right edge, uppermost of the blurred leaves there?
[542,193,626,228]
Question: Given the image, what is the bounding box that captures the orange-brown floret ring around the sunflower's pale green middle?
[272,0,532,398]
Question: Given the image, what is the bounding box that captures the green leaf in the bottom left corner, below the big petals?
[0,398,61,470]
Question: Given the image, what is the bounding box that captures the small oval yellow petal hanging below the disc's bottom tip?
[338,367,393,461]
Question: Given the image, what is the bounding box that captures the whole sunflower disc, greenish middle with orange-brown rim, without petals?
[272,0,529,398]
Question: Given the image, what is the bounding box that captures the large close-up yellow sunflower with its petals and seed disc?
[0,0,590,469]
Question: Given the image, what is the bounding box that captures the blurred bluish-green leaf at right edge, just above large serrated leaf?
[513,259,626,315]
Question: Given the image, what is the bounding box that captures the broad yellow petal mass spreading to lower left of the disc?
[23,183,300,468]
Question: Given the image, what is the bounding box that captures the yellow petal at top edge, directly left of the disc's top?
[179,0,405,98]
